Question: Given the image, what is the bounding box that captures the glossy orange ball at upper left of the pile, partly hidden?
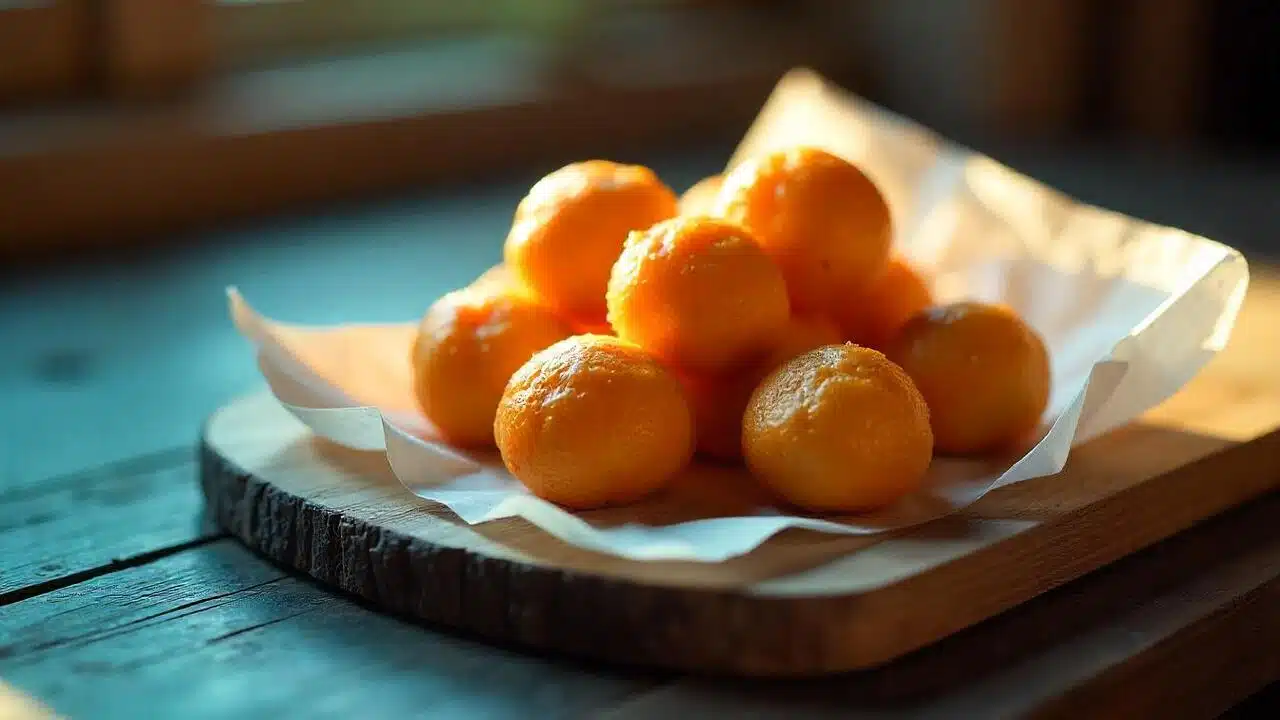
[503,160,676,324]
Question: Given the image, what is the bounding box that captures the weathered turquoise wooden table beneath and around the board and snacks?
[0,142,1280,717]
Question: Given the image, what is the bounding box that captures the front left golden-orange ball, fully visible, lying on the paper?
[494,336,694,510]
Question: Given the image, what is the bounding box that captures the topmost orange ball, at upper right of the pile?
[713,147,892,313]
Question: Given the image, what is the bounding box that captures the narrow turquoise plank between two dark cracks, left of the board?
[0,448,221,606]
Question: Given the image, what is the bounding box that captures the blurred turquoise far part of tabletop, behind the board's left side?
[0,192,513,487]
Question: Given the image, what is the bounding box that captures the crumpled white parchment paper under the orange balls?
[229,70,1248,562]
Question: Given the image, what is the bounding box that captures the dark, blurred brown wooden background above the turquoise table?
[0,0,1280,264]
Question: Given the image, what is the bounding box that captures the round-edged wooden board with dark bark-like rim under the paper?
[201,267,1280,675]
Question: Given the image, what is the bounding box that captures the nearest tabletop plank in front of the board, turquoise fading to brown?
[0,496,1280,717]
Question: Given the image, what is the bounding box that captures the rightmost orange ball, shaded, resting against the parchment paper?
[888,302,1050,454]
